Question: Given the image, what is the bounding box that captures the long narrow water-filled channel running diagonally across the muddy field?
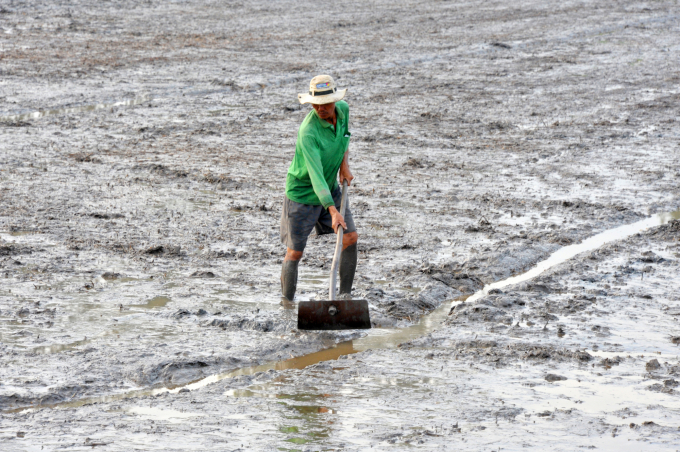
[9,210,680,412]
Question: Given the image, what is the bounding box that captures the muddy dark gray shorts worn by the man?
[281,187,357,251]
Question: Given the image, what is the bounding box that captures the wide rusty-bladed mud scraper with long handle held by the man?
[298,181,371,330]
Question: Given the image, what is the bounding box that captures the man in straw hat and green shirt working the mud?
[281,75,358,301]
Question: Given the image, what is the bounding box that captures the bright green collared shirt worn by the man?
[286,100,350,209]
